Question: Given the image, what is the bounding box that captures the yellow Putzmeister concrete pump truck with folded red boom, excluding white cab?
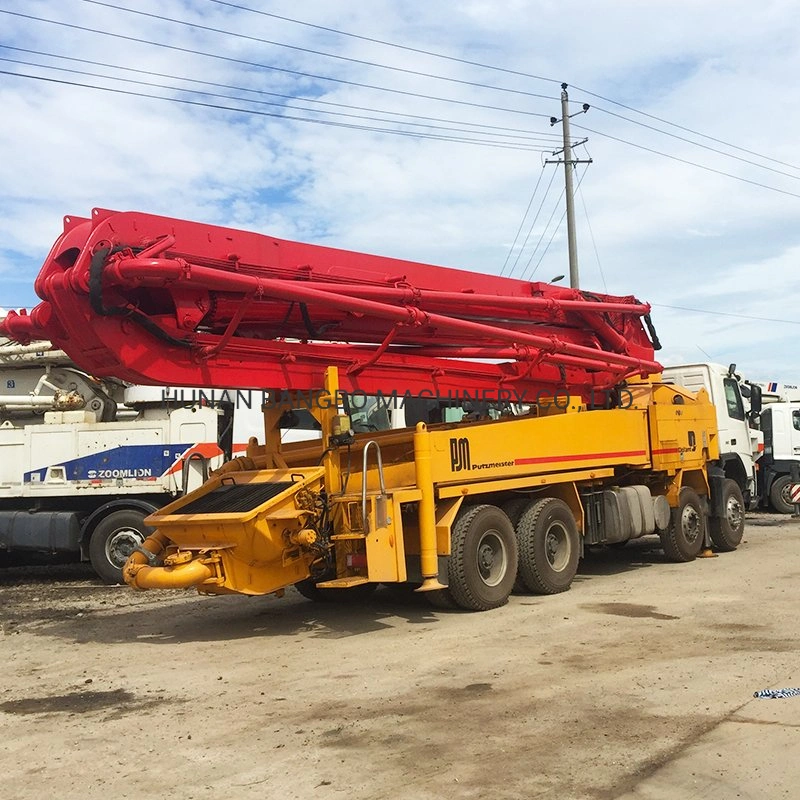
[2,209,744,610]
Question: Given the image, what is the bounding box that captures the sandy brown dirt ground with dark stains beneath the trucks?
[0,514,800,800]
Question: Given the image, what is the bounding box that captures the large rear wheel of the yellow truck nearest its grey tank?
[517,497,580,594]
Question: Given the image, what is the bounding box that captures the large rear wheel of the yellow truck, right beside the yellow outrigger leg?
[447,505,517,611]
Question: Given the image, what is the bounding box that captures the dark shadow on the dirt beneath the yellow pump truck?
[0,537,720,646]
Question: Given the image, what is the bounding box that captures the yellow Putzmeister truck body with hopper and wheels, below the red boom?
[124,369,743,610]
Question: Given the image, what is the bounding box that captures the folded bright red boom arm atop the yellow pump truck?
[0,209,661,397]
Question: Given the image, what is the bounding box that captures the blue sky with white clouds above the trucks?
[0,0,800,384]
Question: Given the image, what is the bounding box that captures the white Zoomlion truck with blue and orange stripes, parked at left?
[0,342,230,583]
